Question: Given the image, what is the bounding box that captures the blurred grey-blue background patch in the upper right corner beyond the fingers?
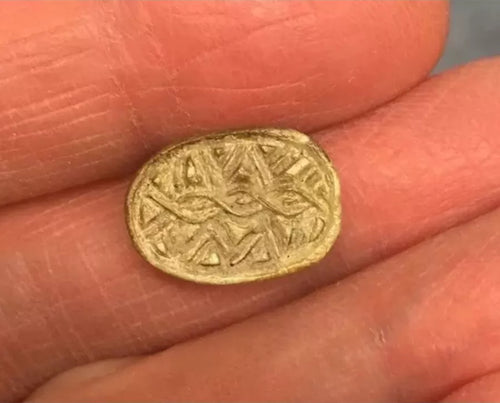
[435,0,500,72]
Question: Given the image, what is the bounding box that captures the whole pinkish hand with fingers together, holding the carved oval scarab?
[0,1,500,402]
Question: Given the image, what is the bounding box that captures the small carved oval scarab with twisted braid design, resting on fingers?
[127,129,341,284]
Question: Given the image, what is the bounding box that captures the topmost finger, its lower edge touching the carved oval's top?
[0,1,448,204]
